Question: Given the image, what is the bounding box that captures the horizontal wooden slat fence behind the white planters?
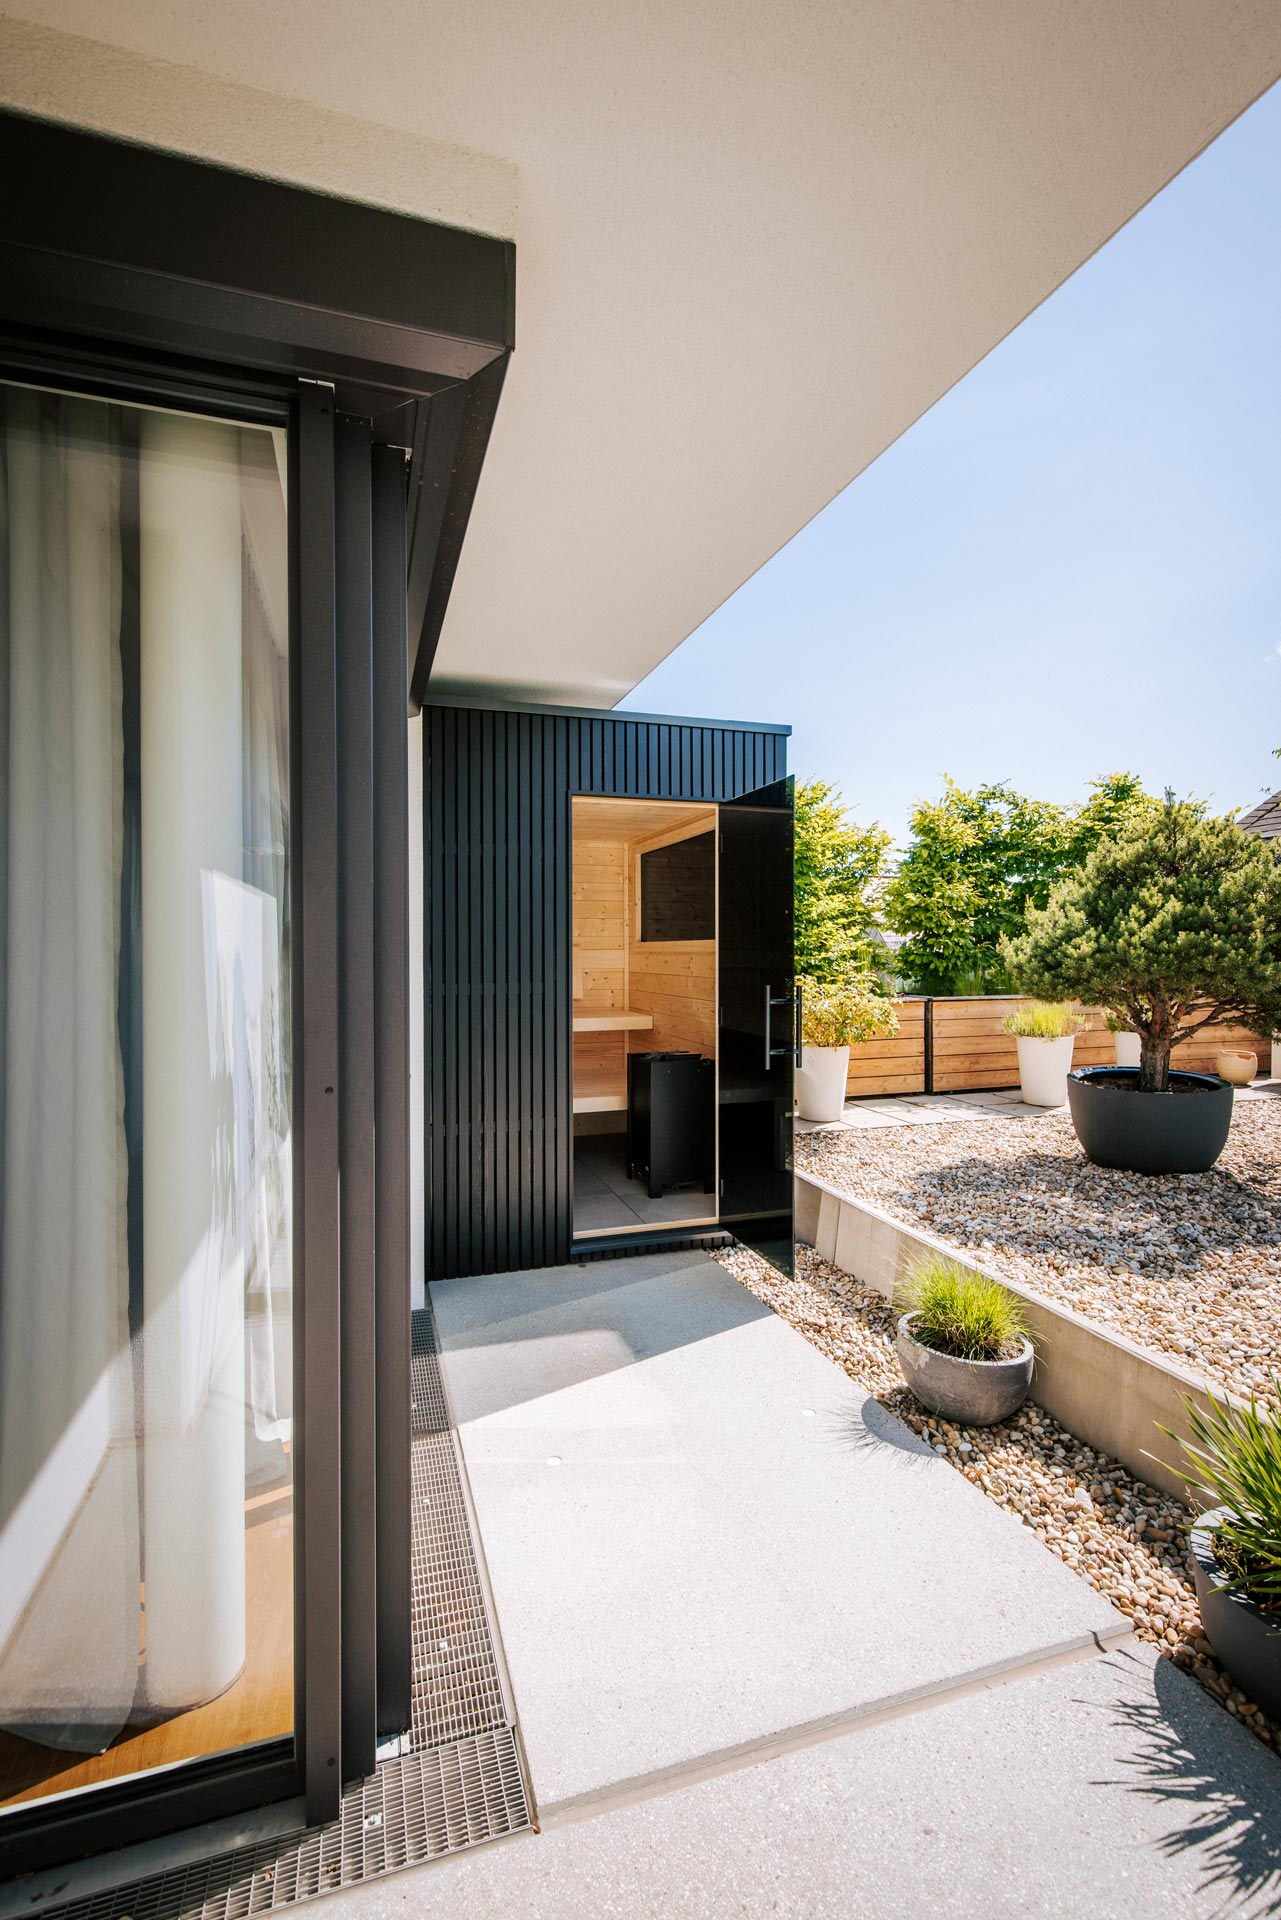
[845,995,1269,1100]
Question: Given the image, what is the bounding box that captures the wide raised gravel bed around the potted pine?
[795,1100,1281,1400]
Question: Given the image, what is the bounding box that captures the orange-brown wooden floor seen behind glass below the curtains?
[0,1482,294,1807]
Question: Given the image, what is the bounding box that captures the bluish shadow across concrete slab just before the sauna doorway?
[432,1252,770,1423]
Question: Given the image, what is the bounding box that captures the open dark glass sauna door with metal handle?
[716,780,799,1271]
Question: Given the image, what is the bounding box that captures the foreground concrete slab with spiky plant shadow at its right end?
[328,1644,1281,1920]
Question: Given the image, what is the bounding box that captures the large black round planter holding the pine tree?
[1068,1068,1233,1173]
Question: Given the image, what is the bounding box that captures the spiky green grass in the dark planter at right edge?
[1162,1379,1281,1613]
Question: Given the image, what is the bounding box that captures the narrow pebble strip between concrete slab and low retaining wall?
[714,1236,1281,1755]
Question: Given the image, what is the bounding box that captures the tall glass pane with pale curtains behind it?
[0,386,294,1807]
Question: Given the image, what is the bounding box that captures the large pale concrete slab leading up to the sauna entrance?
[432,1252,1127,1816]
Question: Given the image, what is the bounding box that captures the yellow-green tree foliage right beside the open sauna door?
[795,780,889,985]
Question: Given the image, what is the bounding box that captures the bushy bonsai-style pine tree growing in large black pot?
[1003,793,1281,1092]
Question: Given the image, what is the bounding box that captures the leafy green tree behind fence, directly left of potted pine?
[885,774,1154,993]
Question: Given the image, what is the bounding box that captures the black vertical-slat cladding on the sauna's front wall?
[423,705,787,1281]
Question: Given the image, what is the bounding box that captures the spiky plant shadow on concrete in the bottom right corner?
[1093,1651,1281,1920]
